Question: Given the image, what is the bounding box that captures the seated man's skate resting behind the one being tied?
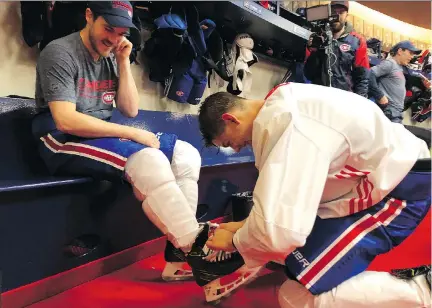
[162,241,194,281]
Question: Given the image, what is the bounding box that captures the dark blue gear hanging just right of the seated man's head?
[144,4,216,105]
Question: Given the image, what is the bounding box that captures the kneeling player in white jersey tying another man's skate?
[199,83,431,308]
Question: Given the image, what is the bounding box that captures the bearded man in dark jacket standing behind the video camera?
[304,1,369,97]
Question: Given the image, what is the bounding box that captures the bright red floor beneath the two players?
[16,212,431,308]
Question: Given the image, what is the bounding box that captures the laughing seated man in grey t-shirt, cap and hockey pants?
[33,1,258,300]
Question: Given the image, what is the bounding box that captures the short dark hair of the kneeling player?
[198,92,245,147]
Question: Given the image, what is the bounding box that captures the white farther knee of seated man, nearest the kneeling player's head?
[171,140,201,182]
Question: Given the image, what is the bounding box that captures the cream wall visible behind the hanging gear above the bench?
[0,2,430,127]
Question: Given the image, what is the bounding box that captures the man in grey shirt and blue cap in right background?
[369,41,421,123]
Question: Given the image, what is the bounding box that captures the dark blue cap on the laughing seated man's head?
[88,1,137,29]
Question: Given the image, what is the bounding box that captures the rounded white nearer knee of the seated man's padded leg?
[125,148,175,196]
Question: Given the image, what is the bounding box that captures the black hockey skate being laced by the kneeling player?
[186,223,261,304]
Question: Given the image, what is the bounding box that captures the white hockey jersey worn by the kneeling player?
[234,83,430,267]
